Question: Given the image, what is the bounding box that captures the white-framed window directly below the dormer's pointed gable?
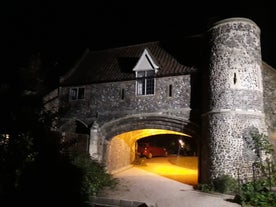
[136,70,155,95]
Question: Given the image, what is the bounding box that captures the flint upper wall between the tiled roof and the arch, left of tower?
[61,75,191,130]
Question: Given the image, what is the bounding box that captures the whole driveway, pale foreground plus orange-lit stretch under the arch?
[96,155,240,207]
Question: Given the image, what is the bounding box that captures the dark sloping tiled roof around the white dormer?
[60,41,196,85]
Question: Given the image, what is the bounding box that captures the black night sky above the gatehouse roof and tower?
[0,0,276,71]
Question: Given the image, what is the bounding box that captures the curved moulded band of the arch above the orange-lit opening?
[101,114,200,140]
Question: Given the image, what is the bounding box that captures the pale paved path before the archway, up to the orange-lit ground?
[99,166,240,207]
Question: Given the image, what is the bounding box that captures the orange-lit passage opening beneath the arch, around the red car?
[106,128,198,185]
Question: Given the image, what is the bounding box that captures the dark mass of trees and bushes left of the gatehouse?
[0,52,117,207]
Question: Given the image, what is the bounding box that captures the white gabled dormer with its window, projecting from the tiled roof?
[133,49,159,95]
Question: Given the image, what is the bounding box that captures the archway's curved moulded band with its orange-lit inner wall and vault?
[100,114,200,173]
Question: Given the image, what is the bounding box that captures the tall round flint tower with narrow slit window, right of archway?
[200,18,266,182]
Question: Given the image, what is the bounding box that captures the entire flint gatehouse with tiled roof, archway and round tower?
[45,18,276,182]
